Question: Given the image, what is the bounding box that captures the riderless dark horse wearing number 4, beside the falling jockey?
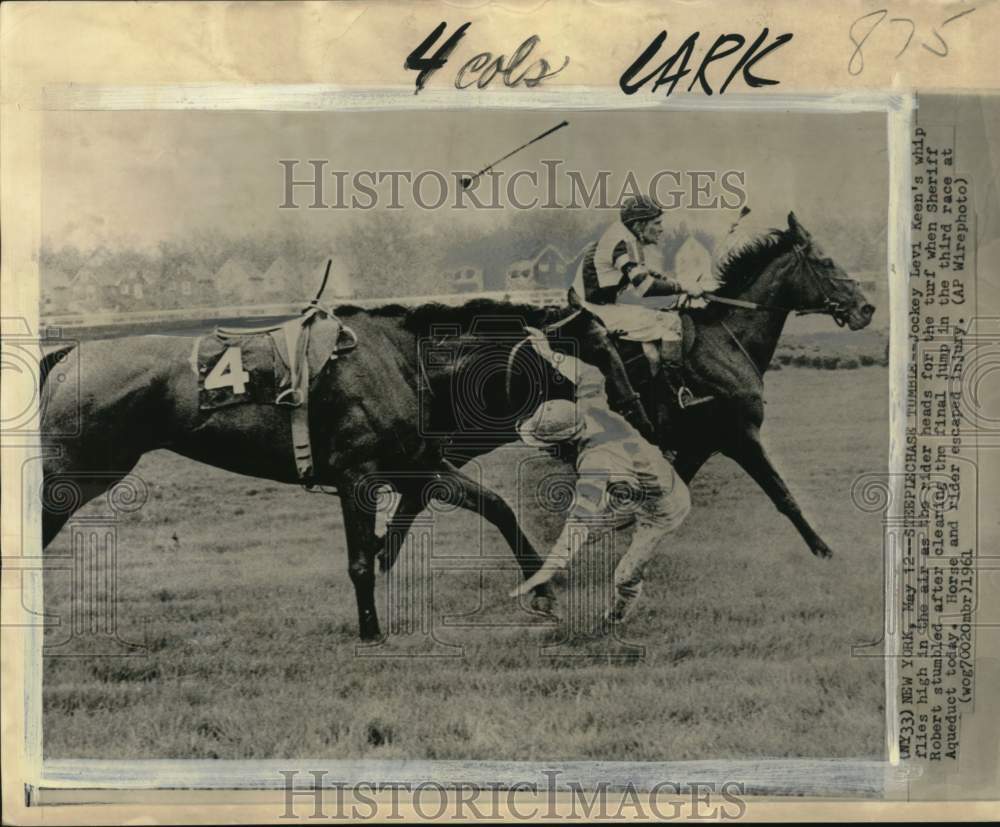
[41,301,588,639]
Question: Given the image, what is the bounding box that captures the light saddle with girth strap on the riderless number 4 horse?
[205,302,358,482]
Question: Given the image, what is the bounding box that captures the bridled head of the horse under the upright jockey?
[785,212,875,330]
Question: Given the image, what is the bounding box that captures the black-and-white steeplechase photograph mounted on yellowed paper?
[38,108,891,772]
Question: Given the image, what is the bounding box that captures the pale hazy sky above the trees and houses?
[42,111,888,249]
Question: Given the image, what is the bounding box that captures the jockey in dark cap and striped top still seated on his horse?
[569,196,702,444]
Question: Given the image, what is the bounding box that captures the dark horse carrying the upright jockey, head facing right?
[383,213,875,584]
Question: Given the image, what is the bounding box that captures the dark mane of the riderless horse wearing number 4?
[335,299,569,335]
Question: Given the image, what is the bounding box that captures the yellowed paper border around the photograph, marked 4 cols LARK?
[0,0,1000,823]
